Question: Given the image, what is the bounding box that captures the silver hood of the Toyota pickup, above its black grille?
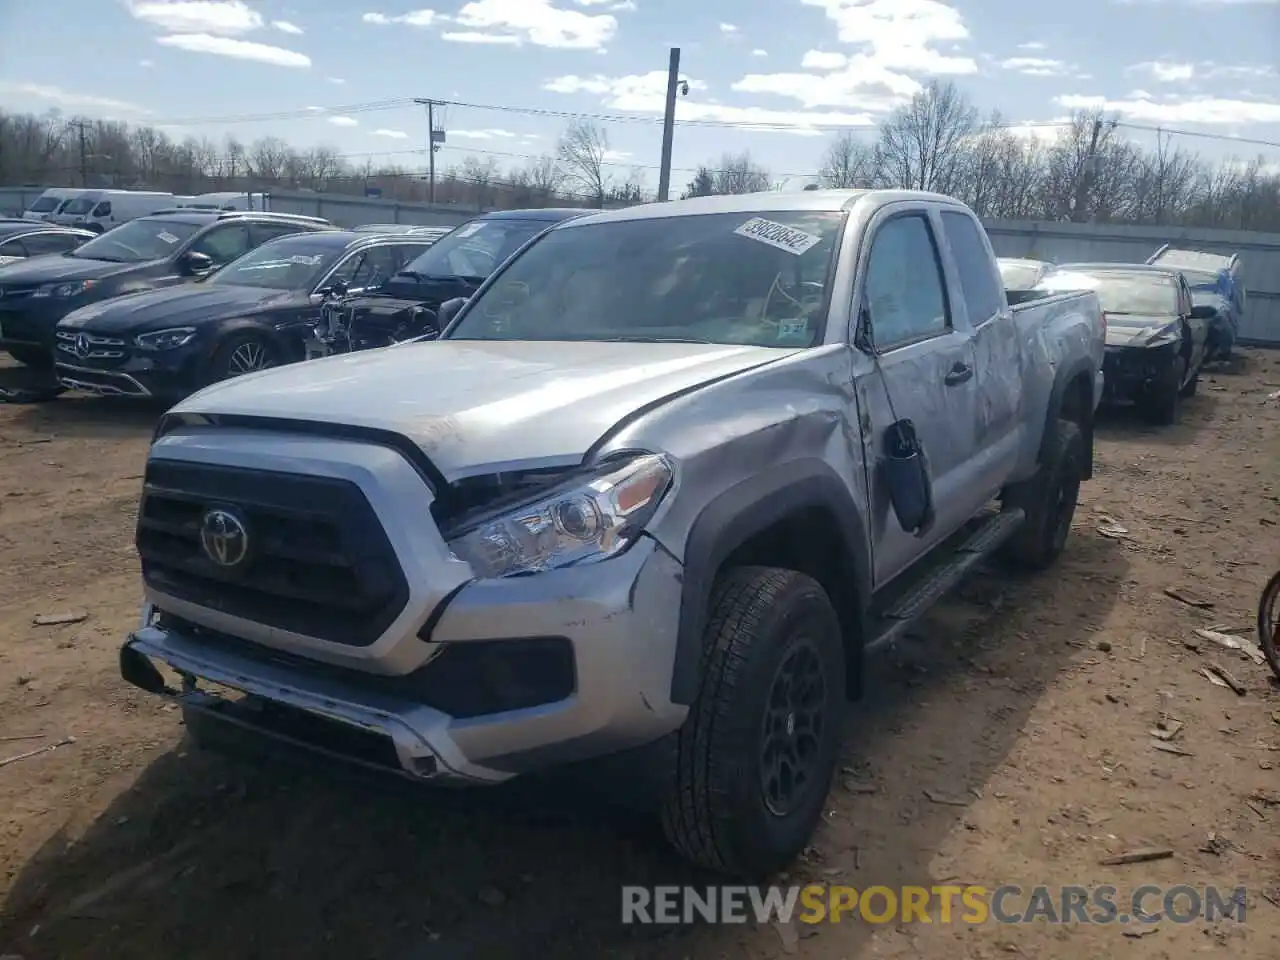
[172,340,796,483]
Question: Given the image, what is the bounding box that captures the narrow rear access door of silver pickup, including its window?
[940,209,1024,500]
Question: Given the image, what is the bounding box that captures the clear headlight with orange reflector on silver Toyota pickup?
[449,454,672,580]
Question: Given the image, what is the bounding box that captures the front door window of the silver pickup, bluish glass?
[864,214,951,351]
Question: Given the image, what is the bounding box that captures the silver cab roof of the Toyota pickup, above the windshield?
[557,189,977,229]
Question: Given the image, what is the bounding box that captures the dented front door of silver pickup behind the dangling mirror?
[855,205,982,585]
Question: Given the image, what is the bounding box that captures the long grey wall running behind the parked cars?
[0,187,1280,347]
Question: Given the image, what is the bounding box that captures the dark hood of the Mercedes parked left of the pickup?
[59,284,307,334]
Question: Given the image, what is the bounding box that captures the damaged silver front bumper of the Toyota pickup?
[120,538,687,783]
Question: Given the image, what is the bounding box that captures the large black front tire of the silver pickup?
[662,567,845,879]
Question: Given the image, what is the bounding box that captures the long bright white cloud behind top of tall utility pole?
[543,70,874,136]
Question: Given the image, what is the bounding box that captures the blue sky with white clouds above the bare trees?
[0,0,1280,188]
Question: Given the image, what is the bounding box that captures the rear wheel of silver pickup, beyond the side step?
[1002,420,1087,570]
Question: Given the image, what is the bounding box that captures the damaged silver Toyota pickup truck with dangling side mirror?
[120,191,1103,877]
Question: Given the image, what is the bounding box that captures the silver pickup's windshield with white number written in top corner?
[442,211,845,348]
